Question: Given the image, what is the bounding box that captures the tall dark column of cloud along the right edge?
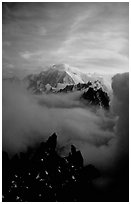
[112,73,129,157]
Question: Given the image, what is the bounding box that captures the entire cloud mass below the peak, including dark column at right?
[3,73,129,172]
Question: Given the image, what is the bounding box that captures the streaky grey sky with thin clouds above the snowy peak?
[2,2,129,77]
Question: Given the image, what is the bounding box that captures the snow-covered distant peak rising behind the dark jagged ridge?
[24,64,110,93]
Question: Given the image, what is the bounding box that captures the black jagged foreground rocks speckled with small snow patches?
[2,133,99,202]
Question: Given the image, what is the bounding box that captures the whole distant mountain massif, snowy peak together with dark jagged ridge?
[3,64,110,109]
